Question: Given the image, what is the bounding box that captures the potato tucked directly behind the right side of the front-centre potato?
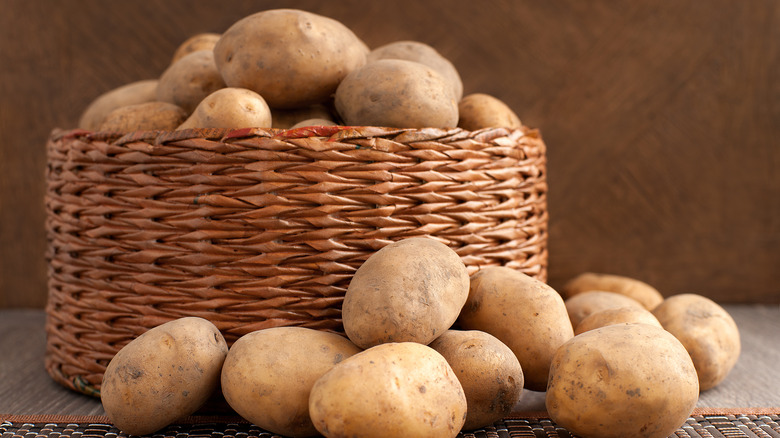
[429,330,523,430]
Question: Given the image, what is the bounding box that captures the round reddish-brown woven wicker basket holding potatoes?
[46,127,547,395]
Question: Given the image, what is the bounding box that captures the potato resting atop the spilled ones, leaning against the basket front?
[342,237,469,348]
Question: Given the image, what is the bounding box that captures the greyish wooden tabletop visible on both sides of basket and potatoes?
[0,305,780,415]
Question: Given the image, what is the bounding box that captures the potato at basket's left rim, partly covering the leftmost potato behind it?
[99,102,187,132]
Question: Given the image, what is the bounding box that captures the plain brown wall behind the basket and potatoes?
[0,0,780,308]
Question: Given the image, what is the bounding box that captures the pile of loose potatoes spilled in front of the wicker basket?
[101,237,740,438]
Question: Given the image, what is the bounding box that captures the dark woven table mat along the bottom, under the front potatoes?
[0,408,780,438]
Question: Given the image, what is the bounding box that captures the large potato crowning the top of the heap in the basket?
[214,9,367,108]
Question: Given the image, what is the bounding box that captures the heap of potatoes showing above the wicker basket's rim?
[79,9,521,132]
